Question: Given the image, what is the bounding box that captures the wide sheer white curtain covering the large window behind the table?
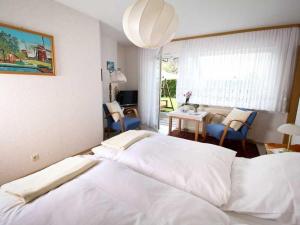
[177,27,299,112]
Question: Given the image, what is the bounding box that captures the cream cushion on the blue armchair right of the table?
[222,108,252,131]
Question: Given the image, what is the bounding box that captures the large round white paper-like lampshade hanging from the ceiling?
[123,0,178,48]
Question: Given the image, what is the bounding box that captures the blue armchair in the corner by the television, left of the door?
[103,104,141,136]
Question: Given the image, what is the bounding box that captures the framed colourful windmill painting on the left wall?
[0,23,55,76]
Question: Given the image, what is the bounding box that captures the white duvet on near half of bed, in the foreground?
[0,160,230,225]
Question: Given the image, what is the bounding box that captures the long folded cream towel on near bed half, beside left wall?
[1,156,98,203]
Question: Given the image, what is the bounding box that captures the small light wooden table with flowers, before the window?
[168,110,208,141]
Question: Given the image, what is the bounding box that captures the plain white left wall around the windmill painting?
[0,0,102,184]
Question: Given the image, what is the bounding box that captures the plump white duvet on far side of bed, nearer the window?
[93,135,236,206]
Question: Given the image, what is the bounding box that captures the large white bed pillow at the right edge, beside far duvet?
[223,153,300,224]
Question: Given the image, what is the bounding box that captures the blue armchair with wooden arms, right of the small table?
[206,109,257,151]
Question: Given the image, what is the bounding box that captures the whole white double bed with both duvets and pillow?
[0,135,300,225]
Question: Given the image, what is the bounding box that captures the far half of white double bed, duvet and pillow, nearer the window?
[94,134,300,224]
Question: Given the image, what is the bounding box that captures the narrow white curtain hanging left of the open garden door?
[139,49,160,129]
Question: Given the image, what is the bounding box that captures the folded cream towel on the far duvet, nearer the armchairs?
[101,130,153,150]
